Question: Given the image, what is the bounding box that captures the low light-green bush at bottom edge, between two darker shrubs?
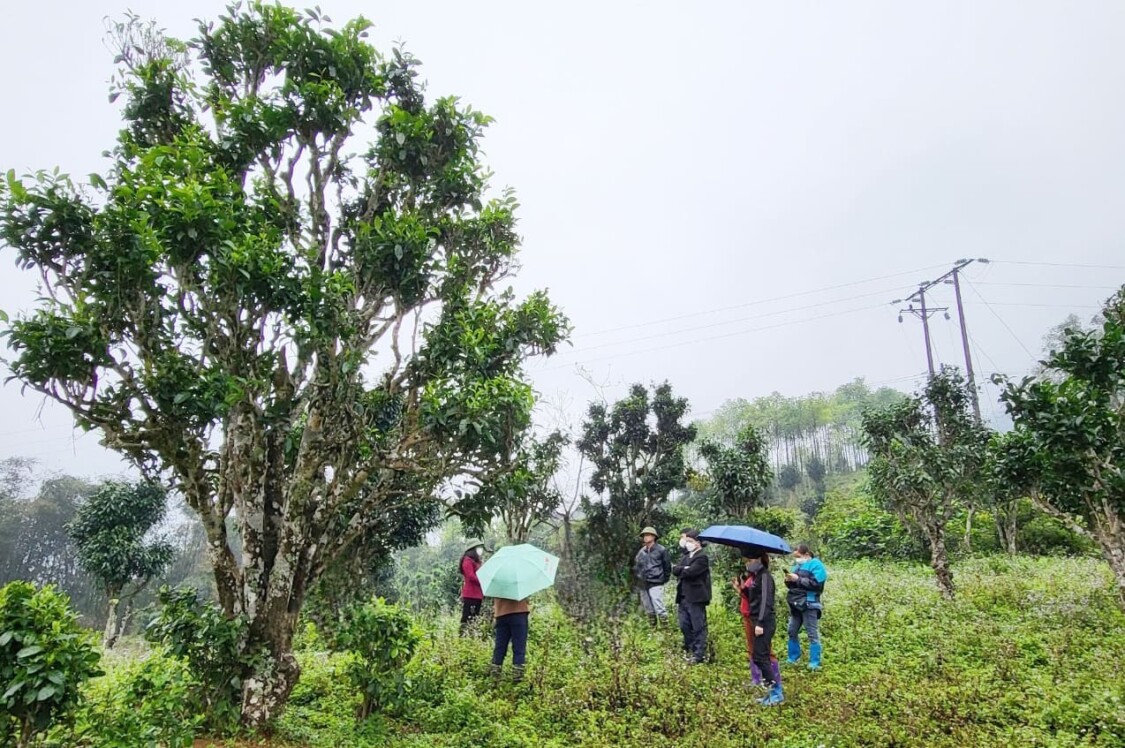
[55,652,203,748]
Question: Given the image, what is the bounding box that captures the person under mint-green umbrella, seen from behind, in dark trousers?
[477,543,559,683]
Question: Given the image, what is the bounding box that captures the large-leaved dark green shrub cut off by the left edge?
[0,582,101,748]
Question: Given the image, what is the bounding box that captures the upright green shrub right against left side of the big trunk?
[145,587,252,732]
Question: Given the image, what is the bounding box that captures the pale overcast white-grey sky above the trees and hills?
[0,0,1125,476]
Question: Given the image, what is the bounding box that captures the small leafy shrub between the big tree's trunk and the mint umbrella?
[335,597,421,719]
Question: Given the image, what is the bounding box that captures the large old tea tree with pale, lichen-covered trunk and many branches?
[0,2,568,726]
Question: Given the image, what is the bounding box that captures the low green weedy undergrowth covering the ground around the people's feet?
[65,557,1125,748]
